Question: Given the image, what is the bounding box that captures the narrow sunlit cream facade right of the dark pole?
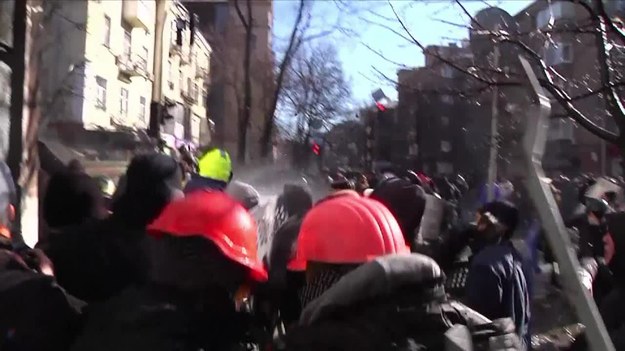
[161,1,212,149]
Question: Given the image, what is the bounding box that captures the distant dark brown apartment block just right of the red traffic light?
[393,43,490,177]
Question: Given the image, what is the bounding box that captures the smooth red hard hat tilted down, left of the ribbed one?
[147,191,267,281]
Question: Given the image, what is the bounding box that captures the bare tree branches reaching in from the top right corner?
[380,0,625,154]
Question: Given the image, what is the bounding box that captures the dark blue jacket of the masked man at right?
[466,241,531,347]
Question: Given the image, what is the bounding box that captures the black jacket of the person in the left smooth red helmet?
[72,285,250,351]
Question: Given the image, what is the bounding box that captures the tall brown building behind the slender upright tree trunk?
[183,0,274,162]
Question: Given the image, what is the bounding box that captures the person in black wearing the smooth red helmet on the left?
[73,191,267,351]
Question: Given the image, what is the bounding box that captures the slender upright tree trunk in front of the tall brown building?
[237,0,254,164]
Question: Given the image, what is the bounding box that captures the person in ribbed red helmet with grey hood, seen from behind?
[285,195,518,351]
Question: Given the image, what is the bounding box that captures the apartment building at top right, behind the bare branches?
[514,0,625,175]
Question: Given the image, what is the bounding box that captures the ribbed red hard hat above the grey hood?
[288,196,410,270]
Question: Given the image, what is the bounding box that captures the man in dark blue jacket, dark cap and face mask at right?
[465,201,530,347]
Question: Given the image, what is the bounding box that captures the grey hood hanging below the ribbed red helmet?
[300,254,445,325]
